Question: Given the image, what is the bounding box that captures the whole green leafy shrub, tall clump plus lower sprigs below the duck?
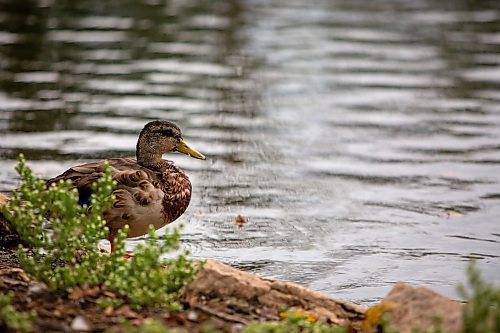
[3,155,199,310]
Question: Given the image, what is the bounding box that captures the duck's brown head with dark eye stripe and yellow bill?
[136,120,205,166]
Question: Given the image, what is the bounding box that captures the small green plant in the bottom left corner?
[0,292,36,332]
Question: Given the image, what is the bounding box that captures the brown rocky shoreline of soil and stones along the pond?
[0,213,463,333]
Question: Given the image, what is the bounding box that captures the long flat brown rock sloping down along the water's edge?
[184,259,366,328]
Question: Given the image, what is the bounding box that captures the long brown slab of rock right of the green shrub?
[183,260,365,329]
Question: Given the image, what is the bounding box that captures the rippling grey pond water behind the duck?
[0,0,500,304]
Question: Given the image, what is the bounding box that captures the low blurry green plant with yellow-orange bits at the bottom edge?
[242,310,347,333]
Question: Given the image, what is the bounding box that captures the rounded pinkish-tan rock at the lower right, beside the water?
[382,282,464,333]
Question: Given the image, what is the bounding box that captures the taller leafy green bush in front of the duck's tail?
[4,155,115,290]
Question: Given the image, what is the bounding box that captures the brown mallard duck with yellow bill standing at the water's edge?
[48,121,205,251]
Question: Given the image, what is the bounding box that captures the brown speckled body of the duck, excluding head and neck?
[49,158,191,237]
